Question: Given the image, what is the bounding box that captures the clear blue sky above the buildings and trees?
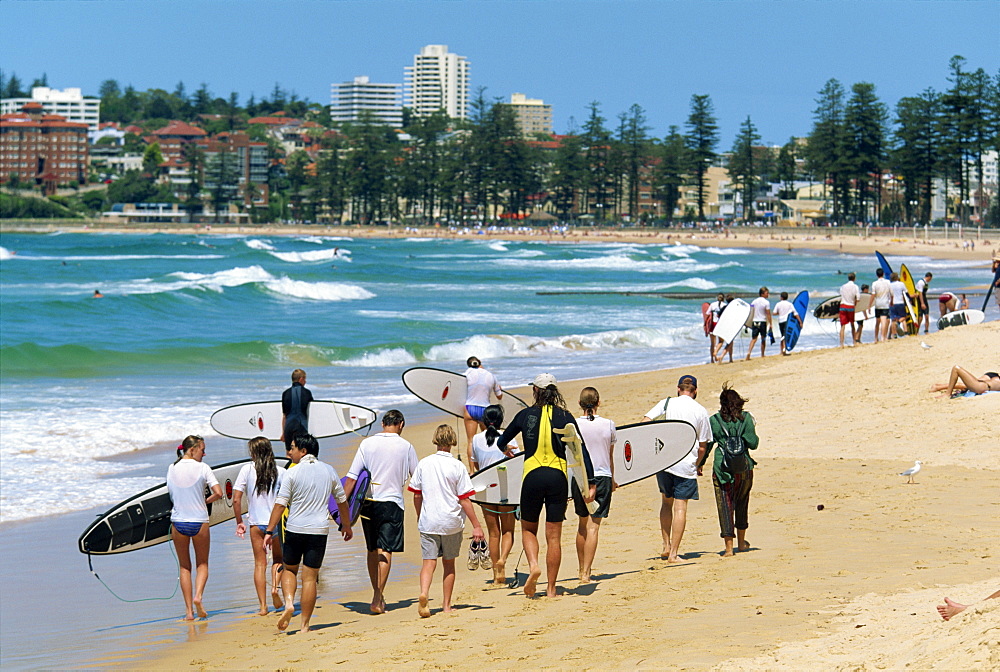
[0,0,1000,149]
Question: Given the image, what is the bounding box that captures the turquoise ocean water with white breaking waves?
[0,234,986,522]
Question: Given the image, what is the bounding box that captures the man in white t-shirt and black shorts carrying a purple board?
[344,410,417,614]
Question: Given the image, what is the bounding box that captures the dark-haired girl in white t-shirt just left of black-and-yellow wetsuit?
[468,404,518,586]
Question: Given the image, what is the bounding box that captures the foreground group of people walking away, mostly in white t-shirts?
[167,358,759,632]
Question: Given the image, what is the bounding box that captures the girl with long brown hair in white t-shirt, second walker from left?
[233,436,285,616]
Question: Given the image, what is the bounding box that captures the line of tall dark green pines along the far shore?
[0,56,1000,224]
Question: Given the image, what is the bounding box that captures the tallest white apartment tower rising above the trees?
[404,44,469,119]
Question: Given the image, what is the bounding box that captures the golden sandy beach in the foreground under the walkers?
[129,321,1000,670]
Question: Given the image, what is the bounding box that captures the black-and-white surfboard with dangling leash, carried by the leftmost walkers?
[78,458,290,555]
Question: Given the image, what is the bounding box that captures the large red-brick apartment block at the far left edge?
[0,101,89,194]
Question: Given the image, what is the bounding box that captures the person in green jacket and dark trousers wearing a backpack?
[705,385,760,558]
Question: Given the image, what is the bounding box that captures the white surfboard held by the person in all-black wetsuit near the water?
[209,399,375,441]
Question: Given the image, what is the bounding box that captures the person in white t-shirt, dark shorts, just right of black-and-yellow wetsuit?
[573,387,618,583]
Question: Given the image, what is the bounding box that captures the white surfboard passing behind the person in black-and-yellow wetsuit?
[471,420,698,505]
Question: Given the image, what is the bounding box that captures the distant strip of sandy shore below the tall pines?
[0,220,1000,264]
